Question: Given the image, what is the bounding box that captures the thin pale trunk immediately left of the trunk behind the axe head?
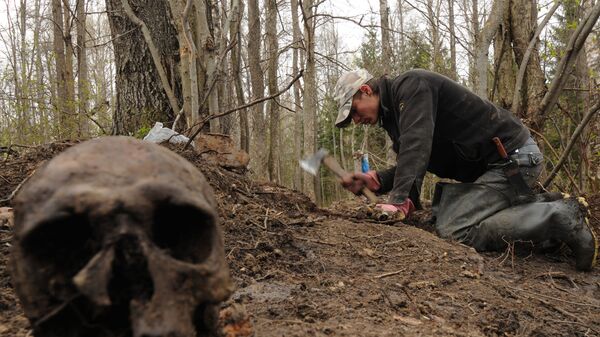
[291,0,304,191]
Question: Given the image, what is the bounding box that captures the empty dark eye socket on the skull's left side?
[21,213,99,276]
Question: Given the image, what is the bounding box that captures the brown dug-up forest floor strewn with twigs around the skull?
[0,143,600,337]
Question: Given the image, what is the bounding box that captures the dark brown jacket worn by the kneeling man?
[377,70,529,203]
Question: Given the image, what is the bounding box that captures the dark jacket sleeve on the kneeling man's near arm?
[378,77,437,203]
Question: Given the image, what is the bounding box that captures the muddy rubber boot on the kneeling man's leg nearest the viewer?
[465,198,598,271]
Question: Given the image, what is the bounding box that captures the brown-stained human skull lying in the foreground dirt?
[11,137,232,337]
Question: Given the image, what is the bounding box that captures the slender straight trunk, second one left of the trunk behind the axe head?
[265,0,279,183]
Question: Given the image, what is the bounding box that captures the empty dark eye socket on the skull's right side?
[152,204,215,263]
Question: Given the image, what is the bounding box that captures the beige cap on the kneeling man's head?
[334,69,373,128]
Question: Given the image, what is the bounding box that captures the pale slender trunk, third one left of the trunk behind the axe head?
[248,0,267,178]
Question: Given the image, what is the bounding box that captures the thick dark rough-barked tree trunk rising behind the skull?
[106,0,183,134]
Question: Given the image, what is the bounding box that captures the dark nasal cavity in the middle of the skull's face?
[108,235,154,304]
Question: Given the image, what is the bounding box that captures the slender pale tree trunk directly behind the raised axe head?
[302,0,321,204]
